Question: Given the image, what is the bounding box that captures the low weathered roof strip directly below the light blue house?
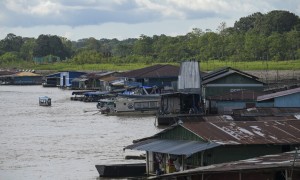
[232,107,300,116]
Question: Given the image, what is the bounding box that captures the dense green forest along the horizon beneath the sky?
[0,10,300,67]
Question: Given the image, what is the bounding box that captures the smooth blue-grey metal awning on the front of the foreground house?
[124,139,220,156]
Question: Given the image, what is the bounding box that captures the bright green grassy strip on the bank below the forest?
[13,60,300,71]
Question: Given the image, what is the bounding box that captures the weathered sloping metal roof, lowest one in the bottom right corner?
[155,151,300,179]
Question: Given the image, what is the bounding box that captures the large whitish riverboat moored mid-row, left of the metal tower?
[97,95,160,115]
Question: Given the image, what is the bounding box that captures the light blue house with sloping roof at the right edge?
[257,88,300,107]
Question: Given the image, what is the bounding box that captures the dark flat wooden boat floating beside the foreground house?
[95,163,146,177]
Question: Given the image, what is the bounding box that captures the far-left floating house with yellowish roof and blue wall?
[0,72,43,85]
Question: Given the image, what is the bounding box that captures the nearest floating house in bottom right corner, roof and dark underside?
[150,151,300,180]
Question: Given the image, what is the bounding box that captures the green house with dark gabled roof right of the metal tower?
[202,67,264,113]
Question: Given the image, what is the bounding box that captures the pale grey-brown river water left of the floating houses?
[0,86,160,180]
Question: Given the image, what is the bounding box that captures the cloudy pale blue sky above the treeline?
[0,0,300,41]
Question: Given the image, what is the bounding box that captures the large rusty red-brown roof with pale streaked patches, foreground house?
[181,120,300,145]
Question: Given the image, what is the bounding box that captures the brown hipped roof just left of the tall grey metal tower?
[120,64,179,78]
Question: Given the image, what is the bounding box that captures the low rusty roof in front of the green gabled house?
[207,90,264,101]
